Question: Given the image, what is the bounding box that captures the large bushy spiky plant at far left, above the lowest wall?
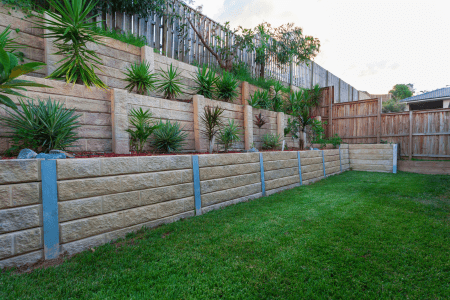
[0,98,80,152]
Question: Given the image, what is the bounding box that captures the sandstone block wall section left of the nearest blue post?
[0,160,43,269]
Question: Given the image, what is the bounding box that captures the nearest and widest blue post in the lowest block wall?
[41,160,59,259]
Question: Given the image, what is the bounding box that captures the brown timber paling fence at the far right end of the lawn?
[321,97,450,159]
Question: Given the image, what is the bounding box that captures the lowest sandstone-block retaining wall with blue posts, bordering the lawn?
[0,145,396,268]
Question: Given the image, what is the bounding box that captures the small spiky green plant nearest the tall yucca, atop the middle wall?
[123,61,157,95]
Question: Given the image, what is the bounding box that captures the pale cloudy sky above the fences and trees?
[193,0,450,94]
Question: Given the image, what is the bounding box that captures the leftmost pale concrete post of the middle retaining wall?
[111,89,130,154]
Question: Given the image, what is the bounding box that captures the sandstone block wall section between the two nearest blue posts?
[57,155,194,253]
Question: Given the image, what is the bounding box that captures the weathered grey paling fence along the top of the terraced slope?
[97,0,359,102]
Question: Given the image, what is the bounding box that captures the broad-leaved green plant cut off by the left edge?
[0,47,49,109]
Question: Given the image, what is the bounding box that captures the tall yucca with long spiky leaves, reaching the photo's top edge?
[36,0,107,89]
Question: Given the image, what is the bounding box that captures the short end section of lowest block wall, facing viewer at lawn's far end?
[348,144,394,172]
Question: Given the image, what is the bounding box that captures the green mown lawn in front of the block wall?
[0,172,450,299]
